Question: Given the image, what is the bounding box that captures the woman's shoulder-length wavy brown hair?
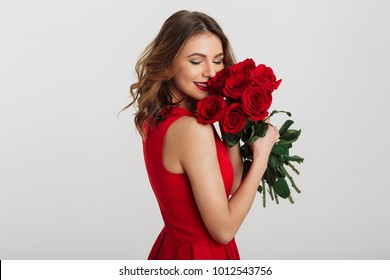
[122,10,235,138]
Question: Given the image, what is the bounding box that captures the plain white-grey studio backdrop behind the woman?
[0,0,390,259]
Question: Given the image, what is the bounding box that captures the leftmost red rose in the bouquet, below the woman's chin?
[196,95,227,124]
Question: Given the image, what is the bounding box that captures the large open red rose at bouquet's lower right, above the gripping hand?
[241,86,272,121]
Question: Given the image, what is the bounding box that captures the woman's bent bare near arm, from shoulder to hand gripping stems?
[172,118,279,244]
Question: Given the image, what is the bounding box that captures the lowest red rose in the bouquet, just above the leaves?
[221,103,246,134]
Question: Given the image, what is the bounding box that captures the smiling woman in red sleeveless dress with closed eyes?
[126,11,279,259]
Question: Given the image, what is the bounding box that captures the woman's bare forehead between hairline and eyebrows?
[182,33,223,56]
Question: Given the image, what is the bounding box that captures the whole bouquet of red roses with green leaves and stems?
[197,59,303,207]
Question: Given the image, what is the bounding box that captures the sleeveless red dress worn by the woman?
[143,107,240,260]
